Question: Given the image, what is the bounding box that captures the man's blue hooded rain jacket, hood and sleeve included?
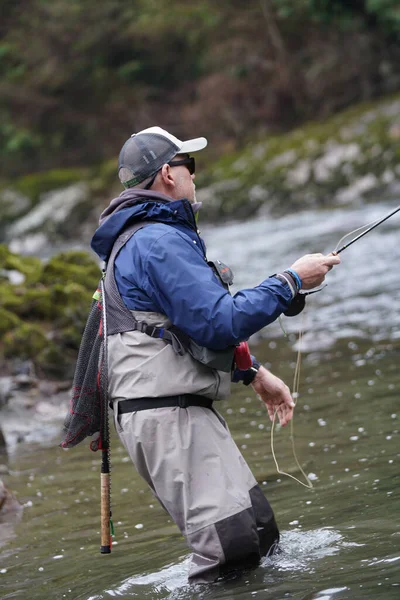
[91,190,292,350]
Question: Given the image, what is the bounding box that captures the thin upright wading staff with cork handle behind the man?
[98,277,113,554]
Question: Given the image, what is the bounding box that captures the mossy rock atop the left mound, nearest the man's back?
[41,250,101,291]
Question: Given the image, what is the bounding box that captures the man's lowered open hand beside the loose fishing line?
[251,366,295,427]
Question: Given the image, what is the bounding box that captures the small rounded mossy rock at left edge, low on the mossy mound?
[3,323,49,360]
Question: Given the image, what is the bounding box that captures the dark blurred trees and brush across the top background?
[0,0,400,177]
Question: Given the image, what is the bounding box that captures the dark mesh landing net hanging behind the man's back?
[60,290,104,448]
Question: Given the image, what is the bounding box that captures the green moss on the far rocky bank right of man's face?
[202,94,400,220]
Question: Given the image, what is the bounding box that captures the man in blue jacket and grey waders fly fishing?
[92,127,340,582]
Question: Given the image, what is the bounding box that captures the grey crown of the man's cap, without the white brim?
[118,133,179,187]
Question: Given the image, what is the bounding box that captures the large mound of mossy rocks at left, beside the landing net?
[0,245,101,379]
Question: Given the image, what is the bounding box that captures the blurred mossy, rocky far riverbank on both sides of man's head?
[0,94,400,256]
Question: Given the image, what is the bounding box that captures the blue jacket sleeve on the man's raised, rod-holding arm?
[123,228,292,350]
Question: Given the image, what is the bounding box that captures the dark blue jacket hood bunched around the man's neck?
[90,189,196,261]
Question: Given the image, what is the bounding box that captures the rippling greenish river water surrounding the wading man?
[0,203,400,600]
